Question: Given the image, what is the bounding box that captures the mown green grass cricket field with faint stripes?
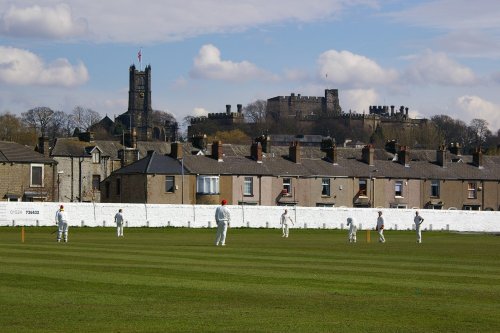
[0,227,500,333]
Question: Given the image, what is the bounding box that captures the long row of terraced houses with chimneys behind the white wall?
[100,138,500,210]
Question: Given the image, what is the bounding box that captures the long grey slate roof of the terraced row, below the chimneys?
[184,144,500,180]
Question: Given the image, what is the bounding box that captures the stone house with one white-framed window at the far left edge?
[0,140,57,201]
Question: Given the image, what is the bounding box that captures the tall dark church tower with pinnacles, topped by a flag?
[125,65,153,141]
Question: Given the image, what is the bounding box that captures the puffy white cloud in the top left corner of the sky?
[0,4,87,39]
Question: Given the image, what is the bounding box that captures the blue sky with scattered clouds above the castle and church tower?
[0,0,500,131]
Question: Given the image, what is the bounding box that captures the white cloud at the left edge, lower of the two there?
[0,46,89,87]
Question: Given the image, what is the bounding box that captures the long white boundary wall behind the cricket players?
[0,202,500,232]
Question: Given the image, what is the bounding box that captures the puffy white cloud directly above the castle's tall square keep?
[317,50,398,88]
